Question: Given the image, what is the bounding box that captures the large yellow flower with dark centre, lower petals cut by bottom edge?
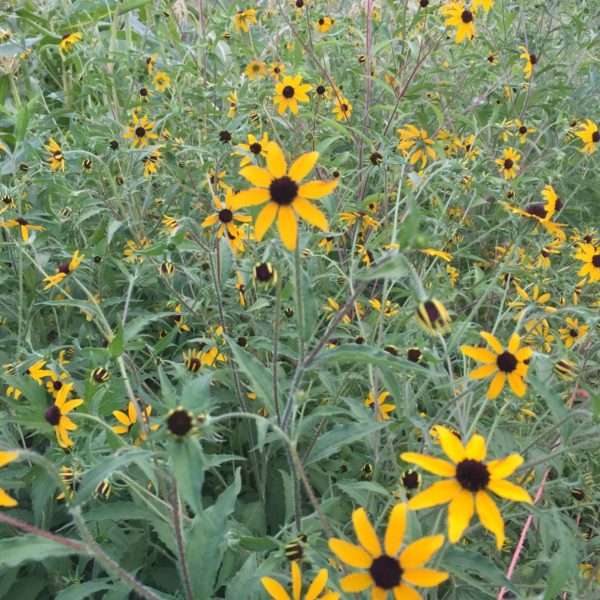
[329,504,448,600]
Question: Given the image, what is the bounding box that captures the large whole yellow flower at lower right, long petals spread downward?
[400,425,532,549]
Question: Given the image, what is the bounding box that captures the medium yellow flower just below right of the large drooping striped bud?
[460,331,533,400]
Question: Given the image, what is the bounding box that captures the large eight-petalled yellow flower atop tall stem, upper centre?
[233,142,339,250]
